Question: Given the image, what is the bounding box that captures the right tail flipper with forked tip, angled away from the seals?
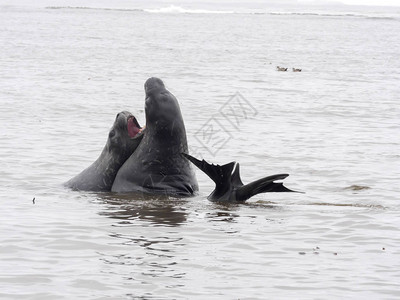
[236,174,295,201]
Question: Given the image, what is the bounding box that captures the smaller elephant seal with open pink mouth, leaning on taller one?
[64,111,143,192]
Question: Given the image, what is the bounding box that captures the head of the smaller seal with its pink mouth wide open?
[107,111,143,159]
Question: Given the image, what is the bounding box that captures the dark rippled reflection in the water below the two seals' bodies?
[93,194,187,290]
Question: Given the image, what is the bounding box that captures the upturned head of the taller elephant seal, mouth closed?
[144,77,184,131]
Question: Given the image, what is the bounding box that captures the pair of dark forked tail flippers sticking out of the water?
[182,153,295,202]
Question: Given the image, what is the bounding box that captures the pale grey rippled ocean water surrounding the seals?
[0,1,400,299]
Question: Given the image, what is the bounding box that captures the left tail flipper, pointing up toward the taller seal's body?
[182,153,236,188]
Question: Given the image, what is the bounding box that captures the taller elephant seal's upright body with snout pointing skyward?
[111,78,198,196]
